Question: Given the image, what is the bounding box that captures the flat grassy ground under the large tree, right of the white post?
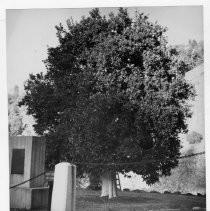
[76,190,206,211]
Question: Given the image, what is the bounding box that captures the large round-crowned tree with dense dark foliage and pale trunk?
[21,8,194,197]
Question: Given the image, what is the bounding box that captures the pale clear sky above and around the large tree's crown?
[6,6,203,92]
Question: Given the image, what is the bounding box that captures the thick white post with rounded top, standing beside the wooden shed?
[51,162,76,211]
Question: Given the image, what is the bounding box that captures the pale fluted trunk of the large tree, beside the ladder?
[101,171,117,199]
